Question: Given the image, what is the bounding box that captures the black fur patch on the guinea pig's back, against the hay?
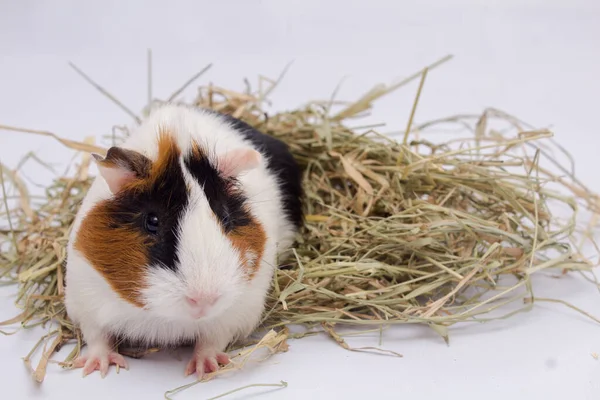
[213,111,304,228]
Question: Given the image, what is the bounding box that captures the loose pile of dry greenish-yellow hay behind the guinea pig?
[0,54,598,381]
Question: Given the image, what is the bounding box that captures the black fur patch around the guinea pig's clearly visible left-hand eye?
[111,147,189,270]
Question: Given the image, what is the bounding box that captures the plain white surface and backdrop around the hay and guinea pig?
[0,0,600,400]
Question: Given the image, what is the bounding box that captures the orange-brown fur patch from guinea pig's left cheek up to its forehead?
[74,130,180,308]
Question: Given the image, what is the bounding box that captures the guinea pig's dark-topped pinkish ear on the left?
[92,147,151,194]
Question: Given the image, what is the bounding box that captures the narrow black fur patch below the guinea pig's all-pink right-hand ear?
[184,148,251,233]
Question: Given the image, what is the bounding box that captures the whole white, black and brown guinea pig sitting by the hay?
[65,104,304,378]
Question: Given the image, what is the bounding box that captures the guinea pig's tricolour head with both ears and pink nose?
[74,134,266,320]
